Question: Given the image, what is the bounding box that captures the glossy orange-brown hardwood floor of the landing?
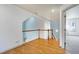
[4,39,64,54]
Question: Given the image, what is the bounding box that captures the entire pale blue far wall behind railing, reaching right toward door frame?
[23,16,59,41]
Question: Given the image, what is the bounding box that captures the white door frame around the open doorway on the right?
[60,4,78,53]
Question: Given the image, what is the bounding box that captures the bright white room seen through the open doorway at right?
[64,5,79,54]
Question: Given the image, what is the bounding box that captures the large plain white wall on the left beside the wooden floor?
[0,5,31,52]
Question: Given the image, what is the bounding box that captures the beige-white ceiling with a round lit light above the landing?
[18,4,62,20]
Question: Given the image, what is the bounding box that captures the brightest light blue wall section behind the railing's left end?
[23,17,38,41]
